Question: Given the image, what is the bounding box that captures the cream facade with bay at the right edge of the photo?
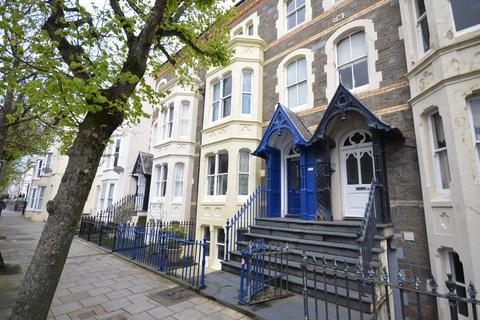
[400,0,480,319]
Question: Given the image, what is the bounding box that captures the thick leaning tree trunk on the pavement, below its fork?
[10,110,123,320]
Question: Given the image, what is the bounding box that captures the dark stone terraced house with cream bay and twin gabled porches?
[197,0,433,318]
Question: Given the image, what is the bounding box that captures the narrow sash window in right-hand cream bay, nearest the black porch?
[430,111,451,192]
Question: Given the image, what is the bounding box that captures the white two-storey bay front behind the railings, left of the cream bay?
[147,78,201,222]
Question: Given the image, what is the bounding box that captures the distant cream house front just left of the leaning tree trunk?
[25,147,68,221]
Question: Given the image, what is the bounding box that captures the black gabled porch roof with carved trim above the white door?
[309,84,403,144]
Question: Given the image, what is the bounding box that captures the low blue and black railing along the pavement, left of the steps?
[79,217,204,289]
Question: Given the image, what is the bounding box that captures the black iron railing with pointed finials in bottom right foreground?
[301,257,480,320]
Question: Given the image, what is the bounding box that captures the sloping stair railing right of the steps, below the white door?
[358,178,379,272]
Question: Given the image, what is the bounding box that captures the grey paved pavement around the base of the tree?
[0,211,253,320]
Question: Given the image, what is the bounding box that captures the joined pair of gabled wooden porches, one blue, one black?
[253,84,403,220]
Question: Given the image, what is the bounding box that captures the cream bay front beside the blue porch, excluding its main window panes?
[196,33,266,268]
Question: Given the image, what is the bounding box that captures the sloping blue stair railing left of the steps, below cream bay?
[225,187,267,261]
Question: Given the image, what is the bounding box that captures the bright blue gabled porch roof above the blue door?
[253,103,312,157]
